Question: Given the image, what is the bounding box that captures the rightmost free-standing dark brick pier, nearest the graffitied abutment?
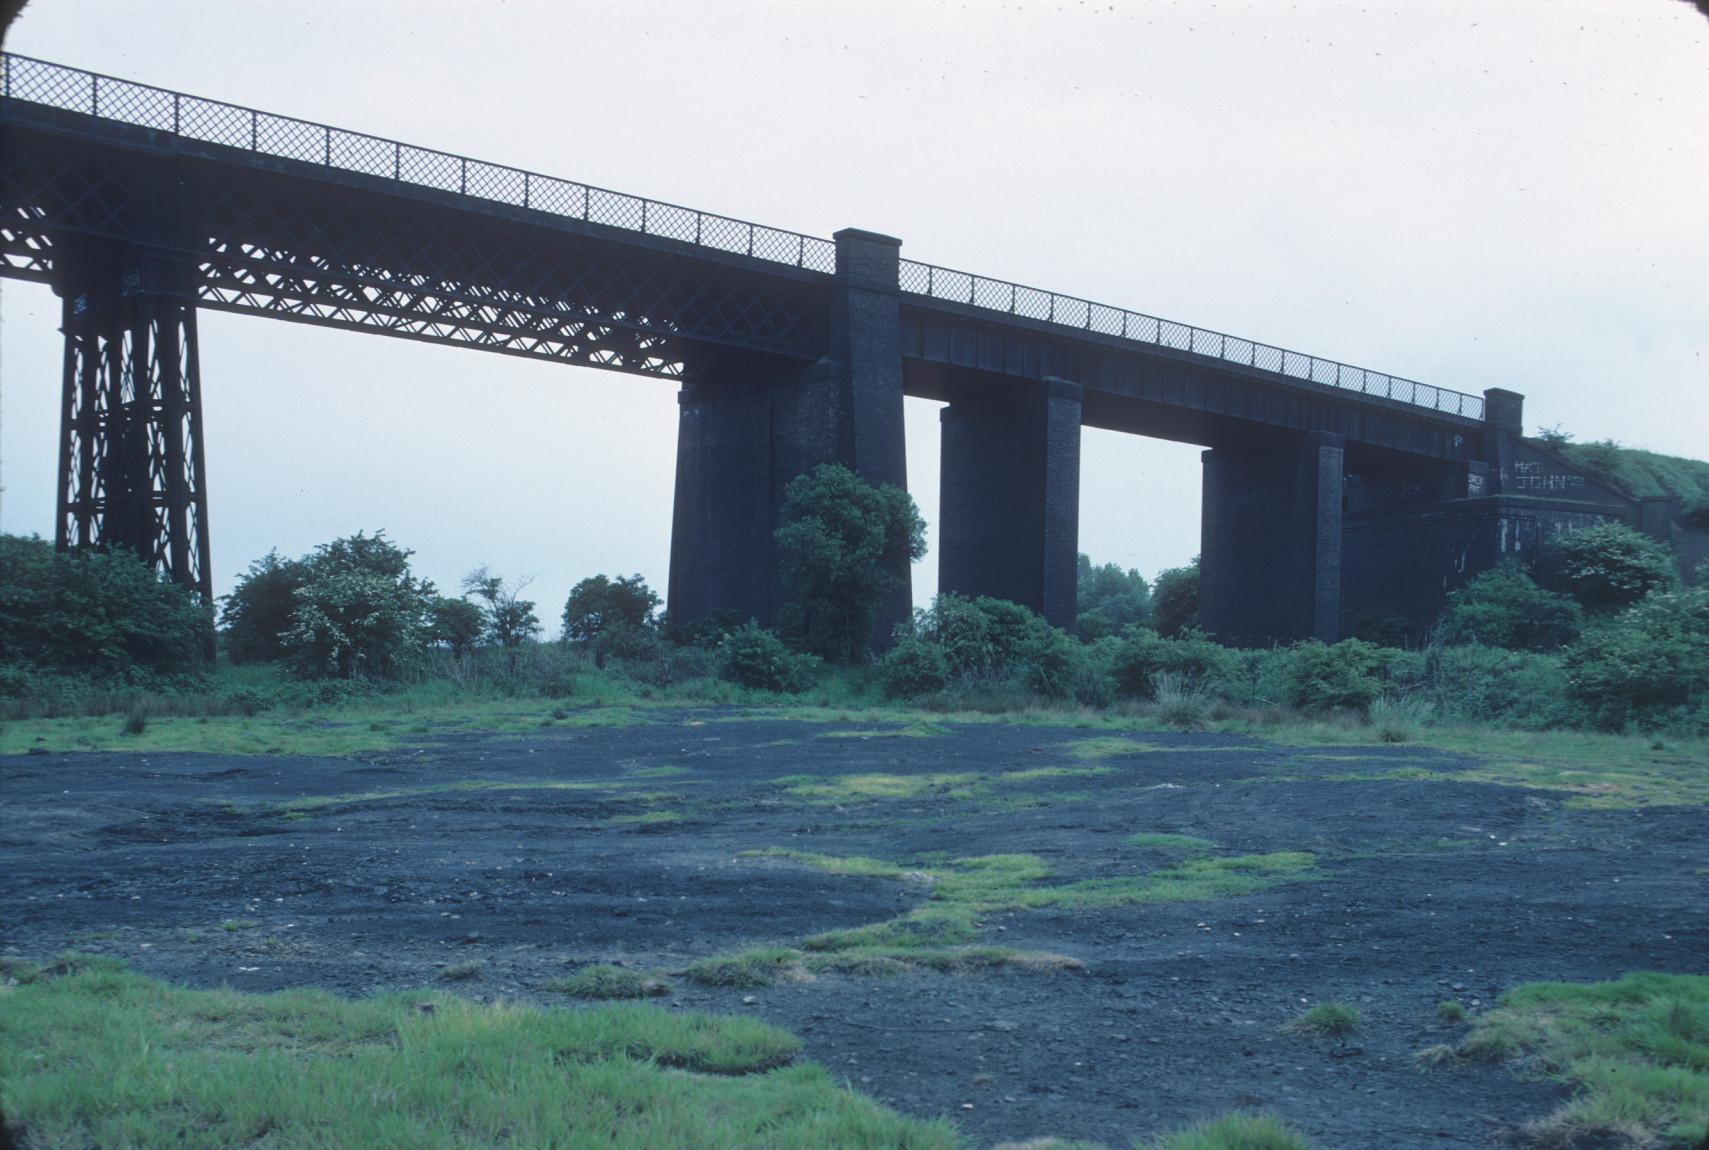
[1198,432,1343,646]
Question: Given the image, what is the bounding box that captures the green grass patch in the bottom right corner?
[1458,972,1709,1147]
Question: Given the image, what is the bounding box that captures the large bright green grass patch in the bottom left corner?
[0,969,964,1150]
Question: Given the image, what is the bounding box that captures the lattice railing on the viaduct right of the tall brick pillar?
[899,260,1483,419]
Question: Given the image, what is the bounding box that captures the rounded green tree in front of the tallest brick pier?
[774,463,926,663]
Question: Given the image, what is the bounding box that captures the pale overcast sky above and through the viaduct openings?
[0,0,1709,618]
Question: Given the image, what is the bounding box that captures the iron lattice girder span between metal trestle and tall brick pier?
[197,181,815,376]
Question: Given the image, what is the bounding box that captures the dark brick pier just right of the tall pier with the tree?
[938,379,1080,627]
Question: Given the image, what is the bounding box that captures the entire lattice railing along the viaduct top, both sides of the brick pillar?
[0,53,1483,419]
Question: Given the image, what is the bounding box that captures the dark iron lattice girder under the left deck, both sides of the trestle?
[0,125,825,376]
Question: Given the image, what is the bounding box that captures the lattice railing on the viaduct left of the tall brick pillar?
[0,53,837,275]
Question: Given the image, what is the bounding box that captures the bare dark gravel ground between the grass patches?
[0,711,1709,1148]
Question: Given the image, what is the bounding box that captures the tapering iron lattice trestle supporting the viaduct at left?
[55,270,214,591]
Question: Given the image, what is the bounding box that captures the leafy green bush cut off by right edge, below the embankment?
[1564,588,1709,730]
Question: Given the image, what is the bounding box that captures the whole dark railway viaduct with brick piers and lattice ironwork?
[0,55,1670,644]
